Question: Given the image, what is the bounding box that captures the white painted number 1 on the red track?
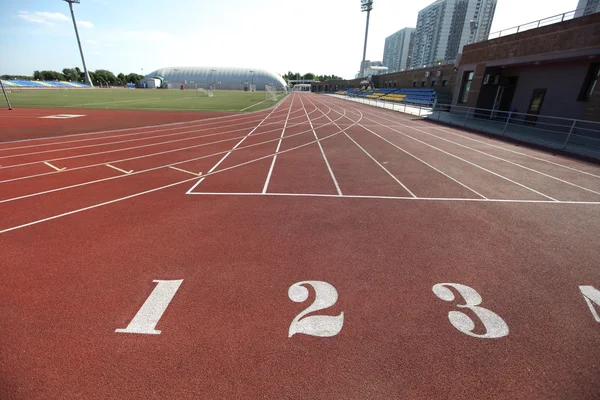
[115,279,183,335]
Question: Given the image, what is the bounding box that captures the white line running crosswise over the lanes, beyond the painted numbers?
[184,192,600,205]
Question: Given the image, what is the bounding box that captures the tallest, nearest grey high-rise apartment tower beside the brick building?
[410,0,497,68]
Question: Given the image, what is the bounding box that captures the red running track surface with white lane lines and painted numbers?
[0,94,600,399]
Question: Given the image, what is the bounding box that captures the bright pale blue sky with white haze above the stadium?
[0,0,577,78]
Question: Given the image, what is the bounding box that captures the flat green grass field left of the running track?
[2,89,285,112]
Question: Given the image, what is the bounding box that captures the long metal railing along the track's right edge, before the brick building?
[332,95,600,160]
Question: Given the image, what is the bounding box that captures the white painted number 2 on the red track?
[288,281,344,337]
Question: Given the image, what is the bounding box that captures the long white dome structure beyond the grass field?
[141,67,287,90]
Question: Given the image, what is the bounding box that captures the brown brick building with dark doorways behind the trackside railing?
[313,13,600,121]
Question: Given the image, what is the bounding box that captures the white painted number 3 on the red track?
[432,283,508,339]
